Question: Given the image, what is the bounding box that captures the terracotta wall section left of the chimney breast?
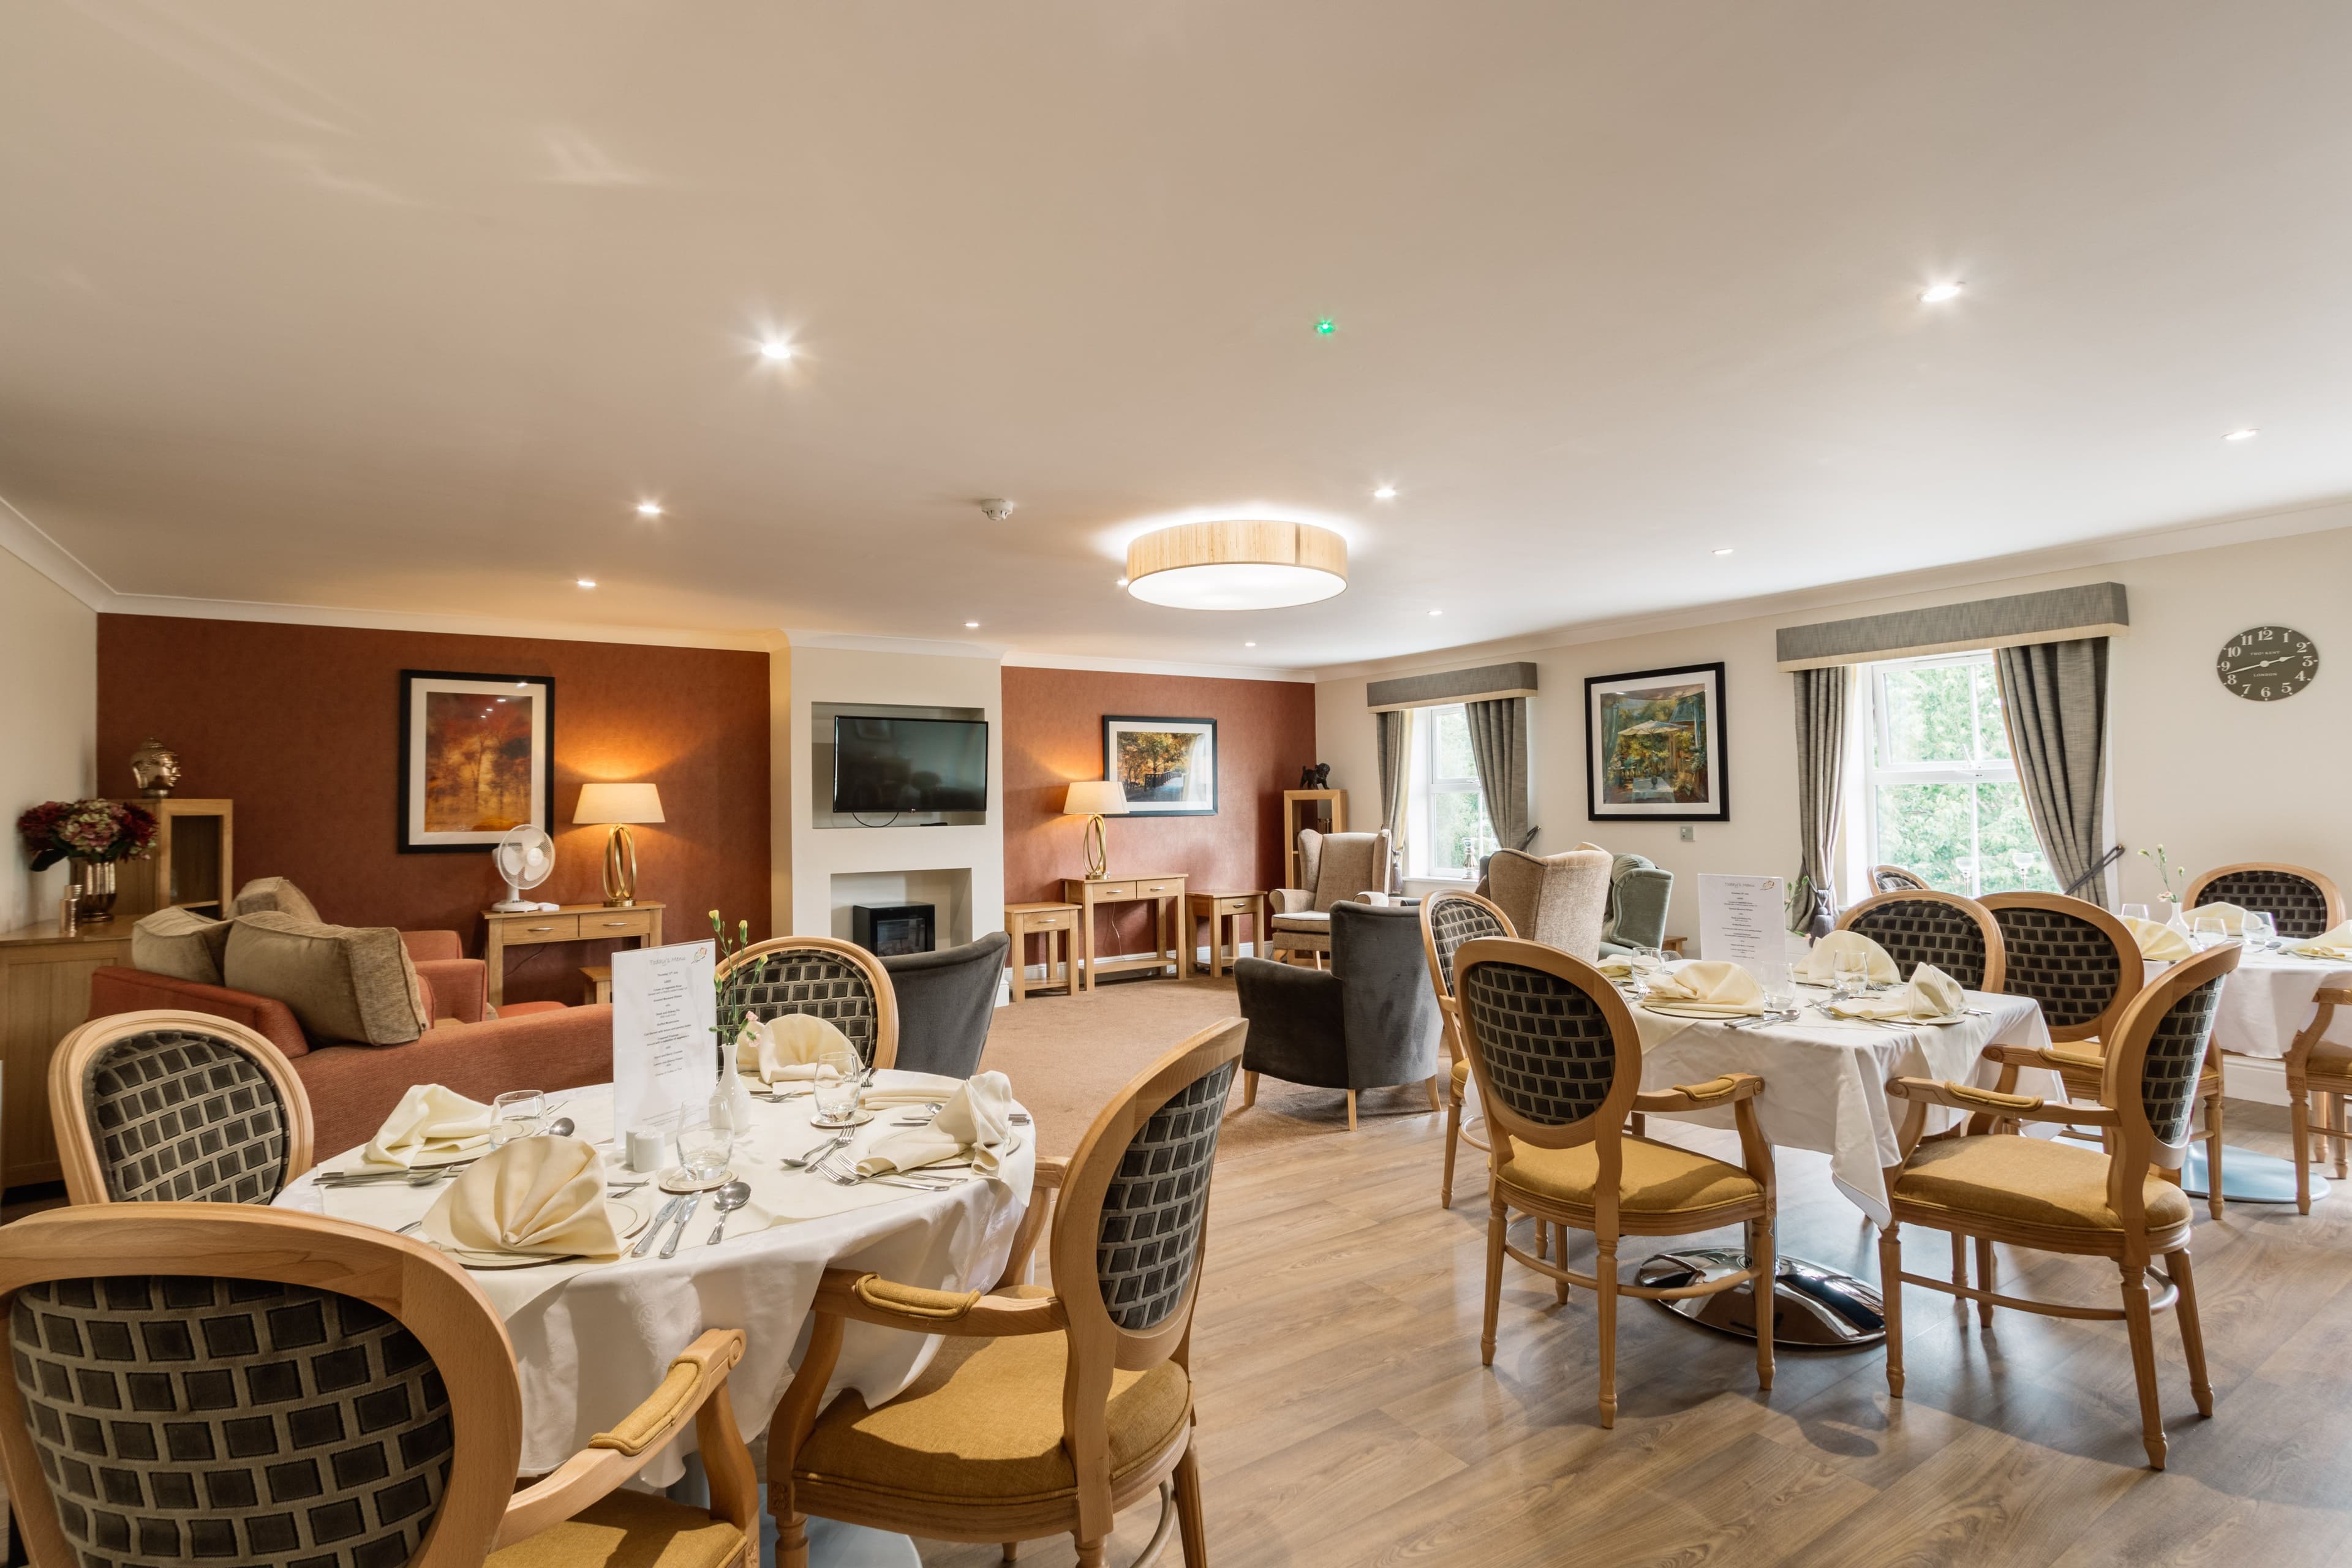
[99,616,769,1001]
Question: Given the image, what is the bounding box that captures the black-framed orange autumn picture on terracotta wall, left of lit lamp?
[400,670,555,853]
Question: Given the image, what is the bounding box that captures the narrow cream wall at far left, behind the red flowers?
[0,550,99,931]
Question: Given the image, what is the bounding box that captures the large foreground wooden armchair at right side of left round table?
[767,1018,1249,1568]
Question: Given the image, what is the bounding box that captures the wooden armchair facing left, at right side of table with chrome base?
[1879,943,2239,1469]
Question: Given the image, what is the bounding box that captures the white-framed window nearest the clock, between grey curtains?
[1860,651,2058,898]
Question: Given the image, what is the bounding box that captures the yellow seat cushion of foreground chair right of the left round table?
[793,1333,1193,1504]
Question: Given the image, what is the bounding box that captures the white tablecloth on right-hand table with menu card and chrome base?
[1632,987,2063,1225]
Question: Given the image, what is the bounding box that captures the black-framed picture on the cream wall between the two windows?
[1585,663,1731,823]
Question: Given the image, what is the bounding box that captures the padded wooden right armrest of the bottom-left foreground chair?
[496,1329,757,1547]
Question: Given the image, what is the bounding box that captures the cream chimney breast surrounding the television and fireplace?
[769,646,1005,945]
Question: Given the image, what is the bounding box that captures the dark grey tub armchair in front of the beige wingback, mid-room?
[1232,902,1442,1131]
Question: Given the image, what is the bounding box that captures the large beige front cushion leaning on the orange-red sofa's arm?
[221,914,433,1046]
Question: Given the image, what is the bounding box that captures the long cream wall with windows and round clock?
[1315,529,2352,936]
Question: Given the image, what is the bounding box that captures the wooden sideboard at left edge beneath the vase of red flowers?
[0,914,132,1187]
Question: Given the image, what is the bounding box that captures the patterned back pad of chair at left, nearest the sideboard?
[82,1030,287,1204]
